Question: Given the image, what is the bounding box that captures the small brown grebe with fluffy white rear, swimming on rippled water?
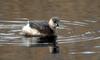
[22,17,60,36]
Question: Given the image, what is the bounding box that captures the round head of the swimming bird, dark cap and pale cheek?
[49,17,60,29]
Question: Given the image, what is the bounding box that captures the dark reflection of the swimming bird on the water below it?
[25,35,59,54]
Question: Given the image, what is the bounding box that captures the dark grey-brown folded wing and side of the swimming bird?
[30,22,54,34]
